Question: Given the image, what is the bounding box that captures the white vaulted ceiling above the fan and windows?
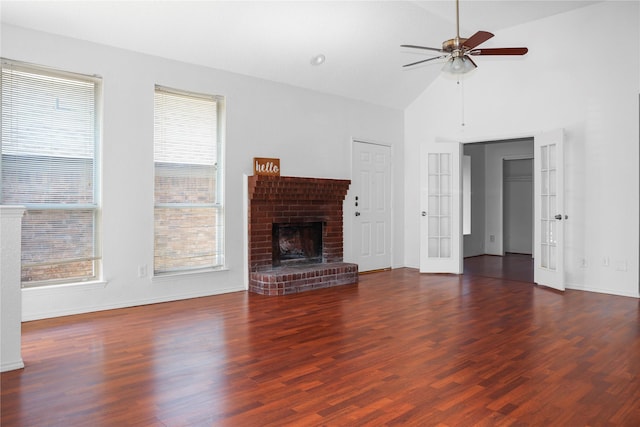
[0,0,597,109]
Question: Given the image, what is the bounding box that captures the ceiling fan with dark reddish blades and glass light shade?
[400,0,529,74]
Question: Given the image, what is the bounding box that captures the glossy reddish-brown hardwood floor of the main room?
[1,269,640,427]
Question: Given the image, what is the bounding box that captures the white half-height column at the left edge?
[0,206,24,372]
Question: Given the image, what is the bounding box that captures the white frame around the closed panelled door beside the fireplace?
[343,137,396,268]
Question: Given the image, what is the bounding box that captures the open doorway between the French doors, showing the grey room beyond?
[463,138,534,282]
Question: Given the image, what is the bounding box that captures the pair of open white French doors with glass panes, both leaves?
[420,129,568,290]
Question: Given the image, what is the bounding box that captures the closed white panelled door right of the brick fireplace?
[351,141,391,271]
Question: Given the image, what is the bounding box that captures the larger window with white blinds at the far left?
[0,59,100,287]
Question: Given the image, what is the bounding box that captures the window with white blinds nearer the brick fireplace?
[154,86,224,275]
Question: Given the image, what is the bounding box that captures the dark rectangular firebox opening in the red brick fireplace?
[272,222,322,267]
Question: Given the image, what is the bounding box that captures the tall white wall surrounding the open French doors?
[405,1,640,297]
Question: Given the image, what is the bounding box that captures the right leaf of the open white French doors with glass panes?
[533,129,567,290]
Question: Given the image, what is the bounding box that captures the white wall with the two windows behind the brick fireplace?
[1,26,404,320]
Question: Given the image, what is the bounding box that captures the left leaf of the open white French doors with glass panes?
[419,142,463,274]
